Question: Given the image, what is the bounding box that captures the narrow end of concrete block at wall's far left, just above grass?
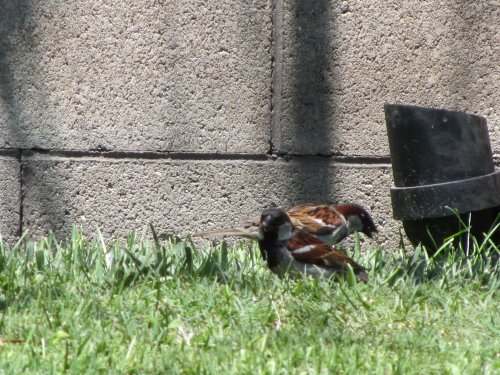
[0,156,21,244]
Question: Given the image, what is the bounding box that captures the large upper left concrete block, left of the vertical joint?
[0,0,271,153]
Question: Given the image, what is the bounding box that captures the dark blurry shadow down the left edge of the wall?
[0,0,64,235]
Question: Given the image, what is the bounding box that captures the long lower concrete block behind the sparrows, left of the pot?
[23,157,399,249]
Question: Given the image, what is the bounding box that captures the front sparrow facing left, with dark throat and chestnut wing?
[259,208,368,283]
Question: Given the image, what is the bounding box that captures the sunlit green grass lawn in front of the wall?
[0,225,500,374]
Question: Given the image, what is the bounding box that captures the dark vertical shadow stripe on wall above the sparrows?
[284,0,335,203]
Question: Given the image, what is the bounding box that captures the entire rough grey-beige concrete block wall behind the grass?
[0,0,500,249]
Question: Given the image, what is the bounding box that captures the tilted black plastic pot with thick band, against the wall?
[384,104,500,252]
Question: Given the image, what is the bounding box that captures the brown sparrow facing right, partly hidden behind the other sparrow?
[193,203,377,245]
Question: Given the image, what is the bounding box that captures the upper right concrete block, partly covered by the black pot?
[274,0,500,156]
